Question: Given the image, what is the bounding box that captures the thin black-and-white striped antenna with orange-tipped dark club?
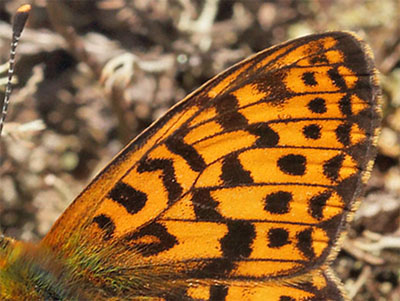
[0,4,31,137]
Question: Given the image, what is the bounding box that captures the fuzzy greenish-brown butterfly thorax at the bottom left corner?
[0,238,87,300]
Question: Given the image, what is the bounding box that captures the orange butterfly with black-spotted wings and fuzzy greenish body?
[0,8,381,301]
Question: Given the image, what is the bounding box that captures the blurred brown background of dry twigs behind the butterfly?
[0,0,400,300]
